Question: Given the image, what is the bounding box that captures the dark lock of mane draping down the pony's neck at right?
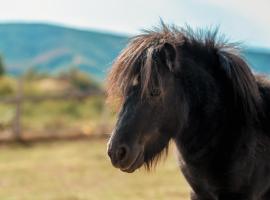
[218,51,260,121]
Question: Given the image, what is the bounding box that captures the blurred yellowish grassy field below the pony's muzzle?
[0,140,189,200]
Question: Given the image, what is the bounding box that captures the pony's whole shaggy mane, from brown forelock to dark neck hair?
[107,22,260,121]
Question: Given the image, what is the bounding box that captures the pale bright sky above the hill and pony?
[0,0,270,48]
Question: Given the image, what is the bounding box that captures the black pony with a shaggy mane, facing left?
[108,24,270,200]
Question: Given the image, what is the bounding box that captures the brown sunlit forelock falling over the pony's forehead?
[107,23,184,105]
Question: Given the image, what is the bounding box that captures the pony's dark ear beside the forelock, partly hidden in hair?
[160,42,179,73]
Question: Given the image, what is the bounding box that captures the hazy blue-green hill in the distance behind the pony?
[0,23,270,79]
